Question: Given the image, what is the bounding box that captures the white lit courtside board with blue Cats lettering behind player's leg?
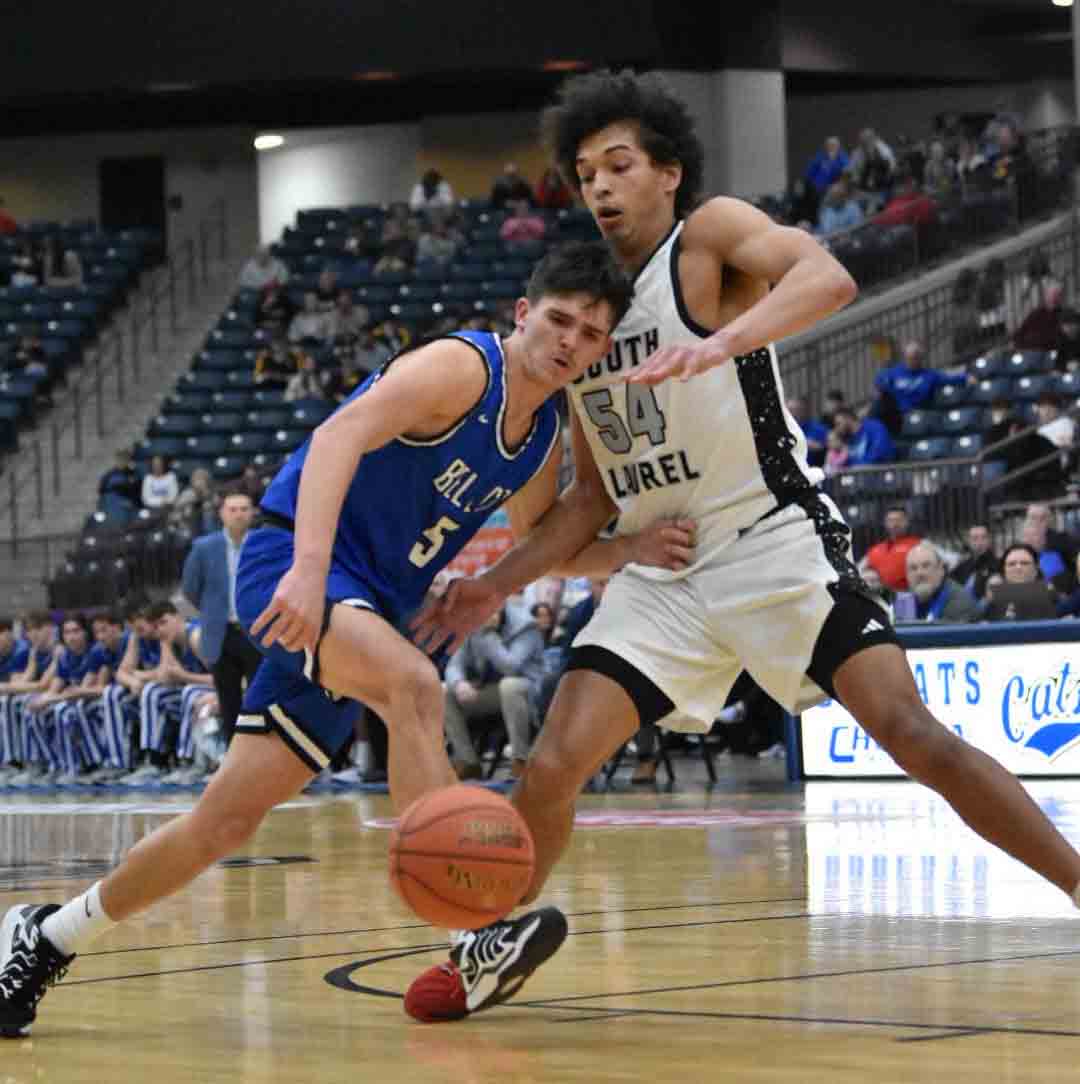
[799,643,1080,778]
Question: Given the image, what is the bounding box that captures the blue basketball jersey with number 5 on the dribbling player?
[262,332,558,619]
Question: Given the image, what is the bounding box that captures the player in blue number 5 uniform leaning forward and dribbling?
[0,243,676,1036]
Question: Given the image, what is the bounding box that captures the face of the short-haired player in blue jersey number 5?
[514,294,613,389]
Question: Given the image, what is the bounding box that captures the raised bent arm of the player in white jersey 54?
[629,197,858,384]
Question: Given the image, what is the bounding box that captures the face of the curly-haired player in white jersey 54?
[577,124,682,251]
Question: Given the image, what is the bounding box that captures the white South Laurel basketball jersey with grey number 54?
[568,222,822,578]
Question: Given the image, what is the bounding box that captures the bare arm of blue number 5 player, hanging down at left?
[252,339,487,651]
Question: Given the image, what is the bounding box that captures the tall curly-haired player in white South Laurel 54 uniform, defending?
[406,72,1080,1019]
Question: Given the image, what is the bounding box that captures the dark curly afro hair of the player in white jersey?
[541,68,705,218]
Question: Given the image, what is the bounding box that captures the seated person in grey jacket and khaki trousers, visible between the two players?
[446,607,544,779]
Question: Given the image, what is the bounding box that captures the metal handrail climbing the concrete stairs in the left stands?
[0,198,228,557]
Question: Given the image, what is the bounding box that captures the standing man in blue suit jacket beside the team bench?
[182,492,261,741]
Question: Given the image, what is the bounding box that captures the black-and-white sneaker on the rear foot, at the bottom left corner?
[0,903,75,1038]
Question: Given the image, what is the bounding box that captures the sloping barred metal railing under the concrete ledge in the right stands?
[780,212,1080,403]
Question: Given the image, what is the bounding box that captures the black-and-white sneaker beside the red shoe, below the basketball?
[450,907,567,1012]
